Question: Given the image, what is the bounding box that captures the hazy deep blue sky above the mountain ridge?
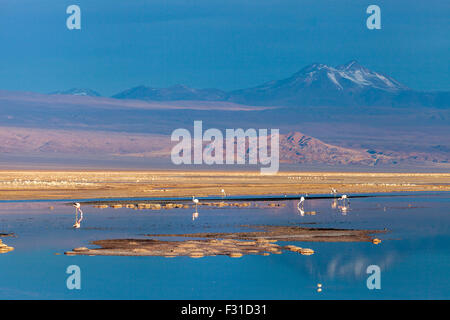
[0,0,450,95]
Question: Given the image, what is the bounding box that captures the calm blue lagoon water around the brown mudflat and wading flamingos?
[0,193,450,299]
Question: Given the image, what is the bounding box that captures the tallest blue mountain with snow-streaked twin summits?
[229,61,410,105]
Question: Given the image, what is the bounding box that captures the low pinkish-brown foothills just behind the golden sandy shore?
[0,127,448,167]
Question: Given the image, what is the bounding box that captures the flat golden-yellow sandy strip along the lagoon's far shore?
[0,170,450,200]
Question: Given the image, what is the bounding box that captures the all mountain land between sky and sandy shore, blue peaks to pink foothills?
[0,61,450,170]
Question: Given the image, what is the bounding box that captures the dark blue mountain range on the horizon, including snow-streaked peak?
[52,61,450,108]
